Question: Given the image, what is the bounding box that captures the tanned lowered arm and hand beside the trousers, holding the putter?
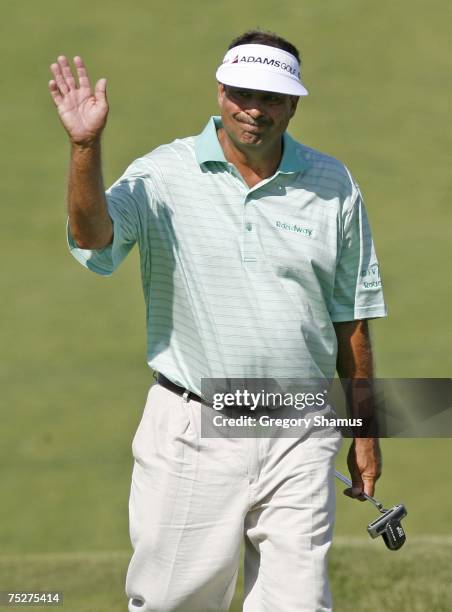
[334,319,381,501]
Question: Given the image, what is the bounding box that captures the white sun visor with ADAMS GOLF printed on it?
[216,45,308,96]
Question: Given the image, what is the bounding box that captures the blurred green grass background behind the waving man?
[0,0,452,612]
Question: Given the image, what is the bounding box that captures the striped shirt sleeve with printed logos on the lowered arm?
[330,190,387,323]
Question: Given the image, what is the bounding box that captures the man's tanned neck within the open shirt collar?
[218,128,282,187]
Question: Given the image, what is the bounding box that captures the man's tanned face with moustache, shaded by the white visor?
[218,83,298,148]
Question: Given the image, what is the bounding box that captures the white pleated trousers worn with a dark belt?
[126,384,341,612]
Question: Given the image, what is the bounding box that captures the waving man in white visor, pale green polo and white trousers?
[49,31,386,612]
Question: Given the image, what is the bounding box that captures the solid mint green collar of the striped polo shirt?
[195,116,309,174]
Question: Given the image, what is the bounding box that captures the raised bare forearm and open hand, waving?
[49,56,113,249]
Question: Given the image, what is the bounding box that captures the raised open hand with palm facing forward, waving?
[49,55,108,144]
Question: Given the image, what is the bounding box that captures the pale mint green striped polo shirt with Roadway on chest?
[68,117,386,394]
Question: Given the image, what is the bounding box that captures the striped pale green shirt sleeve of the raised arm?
[67,160,152,276]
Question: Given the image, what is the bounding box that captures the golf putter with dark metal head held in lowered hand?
[335,470,408,550]
